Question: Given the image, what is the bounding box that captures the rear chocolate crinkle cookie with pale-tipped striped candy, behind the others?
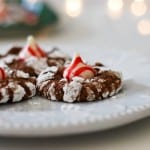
[0,36,70,77]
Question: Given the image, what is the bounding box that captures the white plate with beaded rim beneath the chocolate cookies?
[0,48,150,136]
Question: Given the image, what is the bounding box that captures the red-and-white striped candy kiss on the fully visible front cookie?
[63,55,95,80]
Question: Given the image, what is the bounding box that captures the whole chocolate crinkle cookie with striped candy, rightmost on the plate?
[37,56,122,102]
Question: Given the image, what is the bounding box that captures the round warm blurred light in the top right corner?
[131,0,147,16]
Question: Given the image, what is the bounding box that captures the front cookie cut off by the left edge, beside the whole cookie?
[0,68,36,103]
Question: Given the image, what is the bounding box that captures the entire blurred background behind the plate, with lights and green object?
[0,0,150,56]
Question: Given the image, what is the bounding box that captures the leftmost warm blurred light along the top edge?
[65,0,82,17]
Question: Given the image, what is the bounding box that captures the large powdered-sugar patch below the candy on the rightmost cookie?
[63,77,84,102]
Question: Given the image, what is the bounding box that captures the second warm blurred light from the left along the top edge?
[107,0,123,19]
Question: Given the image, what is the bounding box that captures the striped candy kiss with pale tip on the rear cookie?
[19,36,46,59]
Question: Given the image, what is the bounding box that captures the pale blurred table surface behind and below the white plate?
[0,0,150,150]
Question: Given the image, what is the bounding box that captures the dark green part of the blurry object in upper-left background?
[0,3,58,38]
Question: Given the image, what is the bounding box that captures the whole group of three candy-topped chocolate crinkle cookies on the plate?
[0,36,122,103]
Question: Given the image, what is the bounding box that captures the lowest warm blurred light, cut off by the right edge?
[137,19,150,35]
